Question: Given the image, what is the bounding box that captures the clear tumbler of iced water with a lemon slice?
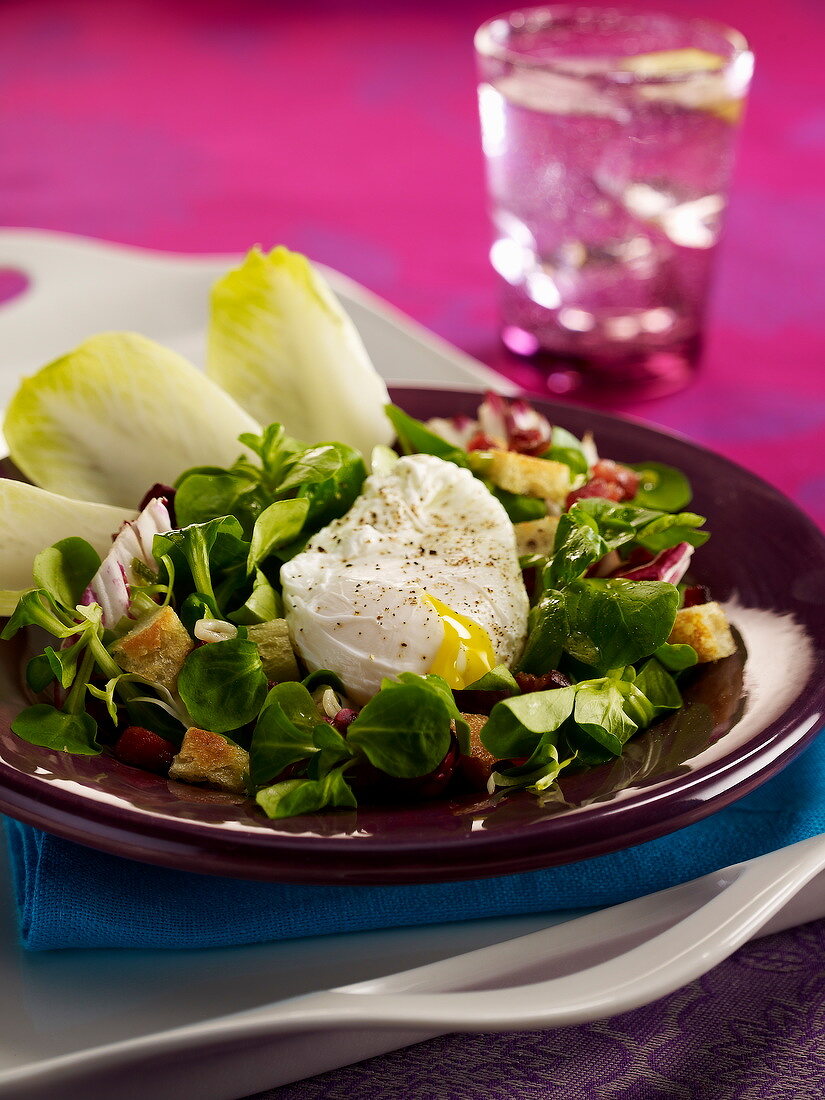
[475,7,754,393]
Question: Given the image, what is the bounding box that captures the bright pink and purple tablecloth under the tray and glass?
[0,0,825,1100]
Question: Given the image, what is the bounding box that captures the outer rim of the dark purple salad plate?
[0,385,825,886]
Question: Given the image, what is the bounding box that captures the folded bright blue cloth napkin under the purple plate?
[7,737,825,950]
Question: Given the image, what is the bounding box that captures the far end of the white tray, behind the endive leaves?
[0,229,516,408]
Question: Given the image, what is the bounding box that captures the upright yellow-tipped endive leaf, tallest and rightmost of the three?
[207,248,393,455]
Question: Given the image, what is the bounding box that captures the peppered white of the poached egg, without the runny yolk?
[281,454,529,702]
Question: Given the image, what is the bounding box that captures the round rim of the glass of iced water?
[473,3,752,85]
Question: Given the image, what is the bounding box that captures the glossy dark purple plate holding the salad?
[0,388,825,883]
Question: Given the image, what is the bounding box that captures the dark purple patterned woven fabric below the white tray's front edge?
[265,921,825,1100]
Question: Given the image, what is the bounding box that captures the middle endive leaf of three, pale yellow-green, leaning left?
[3,332,261,508]
